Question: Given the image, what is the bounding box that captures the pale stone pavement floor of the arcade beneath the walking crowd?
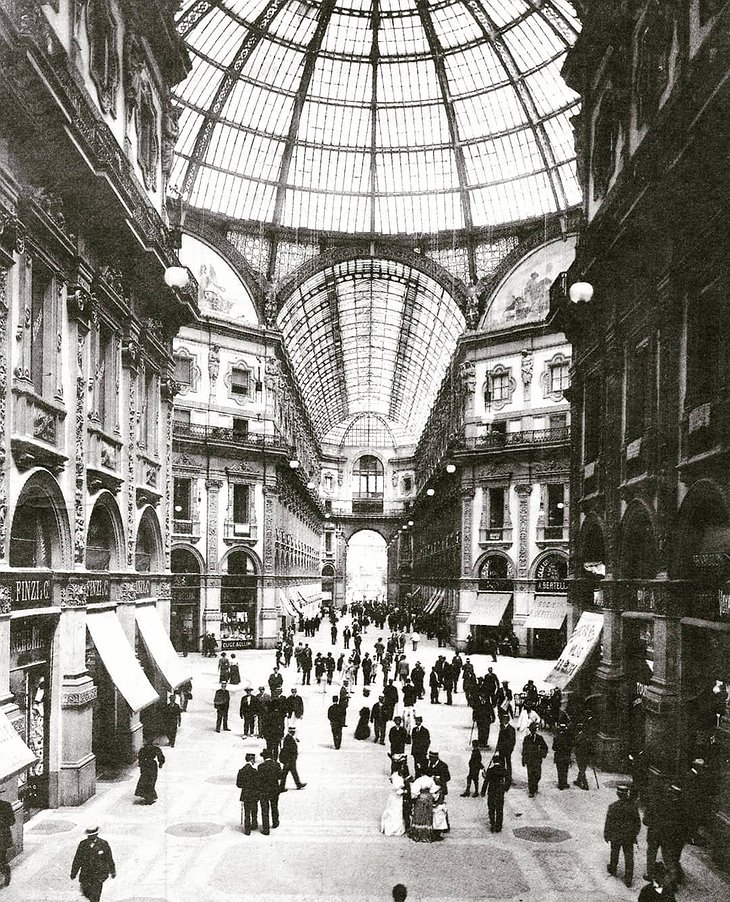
[7,624,730,902]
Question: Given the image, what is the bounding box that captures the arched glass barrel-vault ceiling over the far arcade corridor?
[278,259,464,443]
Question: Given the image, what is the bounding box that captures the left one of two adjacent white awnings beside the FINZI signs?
[86,611,159,711]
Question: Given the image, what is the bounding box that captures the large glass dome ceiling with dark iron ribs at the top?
[171,0,580,234]
